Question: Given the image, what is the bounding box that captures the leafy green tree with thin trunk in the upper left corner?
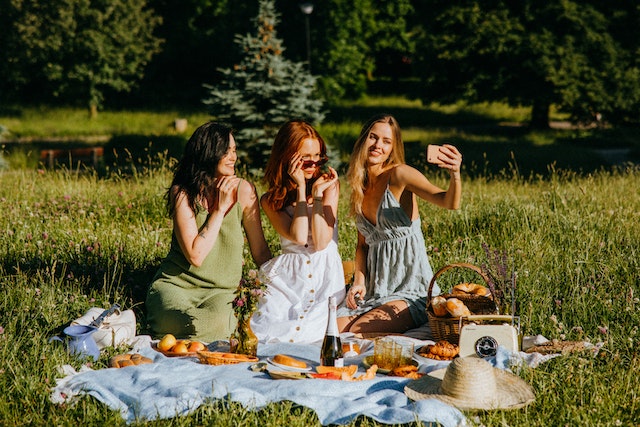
[4,0,161,114]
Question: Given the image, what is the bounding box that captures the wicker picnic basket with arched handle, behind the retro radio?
[427,263,498,344]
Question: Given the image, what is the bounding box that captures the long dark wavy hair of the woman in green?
[166,122,233,217]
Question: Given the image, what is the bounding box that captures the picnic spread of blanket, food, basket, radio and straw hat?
[50,264,601,427]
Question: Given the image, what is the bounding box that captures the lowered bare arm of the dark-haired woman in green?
[238,180,272,266]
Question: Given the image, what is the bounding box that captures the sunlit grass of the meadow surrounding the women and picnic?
[0,101,640,426]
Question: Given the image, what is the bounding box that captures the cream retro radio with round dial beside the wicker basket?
[460,315,520,358]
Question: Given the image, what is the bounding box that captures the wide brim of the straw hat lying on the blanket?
[404,367,535,410]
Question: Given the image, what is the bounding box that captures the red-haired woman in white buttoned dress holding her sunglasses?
[251,120,345,343]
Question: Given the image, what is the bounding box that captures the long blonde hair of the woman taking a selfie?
[347,114,404,215]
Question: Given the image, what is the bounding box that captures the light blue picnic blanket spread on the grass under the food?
[51,336,568,427]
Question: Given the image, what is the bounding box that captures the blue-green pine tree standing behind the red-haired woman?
[203,0,324,172]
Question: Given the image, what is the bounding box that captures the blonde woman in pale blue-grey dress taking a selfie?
[338,115,462,335]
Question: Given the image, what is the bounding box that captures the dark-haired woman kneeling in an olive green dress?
[146,122,271,342]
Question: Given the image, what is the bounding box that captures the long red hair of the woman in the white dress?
[264,120,327,211]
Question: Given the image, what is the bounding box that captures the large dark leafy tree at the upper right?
[415,0,637,127]
